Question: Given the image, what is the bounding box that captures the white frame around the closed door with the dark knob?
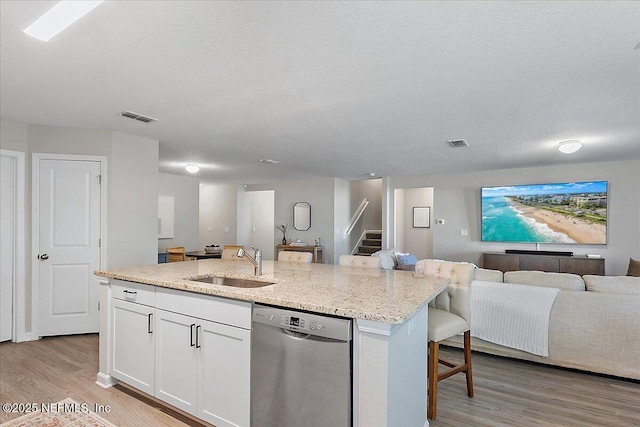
[31,153,108,340]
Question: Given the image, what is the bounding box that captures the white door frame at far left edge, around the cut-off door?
[0,149,25,342]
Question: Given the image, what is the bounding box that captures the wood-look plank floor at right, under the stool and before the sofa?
[429,347,640,427]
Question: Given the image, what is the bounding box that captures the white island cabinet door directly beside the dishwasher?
[196,320,251,427]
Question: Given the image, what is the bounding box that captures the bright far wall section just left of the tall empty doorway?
[198,182,239,249]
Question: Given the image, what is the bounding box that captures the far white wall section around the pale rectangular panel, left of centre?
[158,173,200,252]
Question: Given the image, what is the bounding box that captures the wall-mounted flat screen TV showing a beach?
[481,181,608,245]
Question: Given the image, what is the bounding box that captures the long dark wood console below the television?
[482,252,604,276]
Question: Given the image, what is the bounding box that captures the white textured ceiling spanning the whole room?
[0,0,640,183]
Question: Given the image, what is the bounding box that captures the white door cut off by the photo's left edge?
[0,155,17,341]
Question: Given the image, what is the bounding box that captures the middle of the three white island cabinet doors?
[155,309,198,415]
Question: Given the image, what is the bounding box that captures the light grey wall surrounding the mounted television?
[392,160,640,275]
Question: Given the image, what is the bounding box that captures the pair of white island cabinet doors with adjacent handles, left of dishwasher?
[155,309,251,427]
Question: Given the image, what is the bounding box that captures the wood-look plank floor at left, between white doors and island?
[0,334,200,427]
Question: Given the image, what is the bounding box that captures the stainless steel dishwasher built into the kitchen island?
[251,304,352,427]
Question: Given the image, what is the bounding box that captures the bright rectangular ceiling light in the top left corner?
[23,0,103,42]
